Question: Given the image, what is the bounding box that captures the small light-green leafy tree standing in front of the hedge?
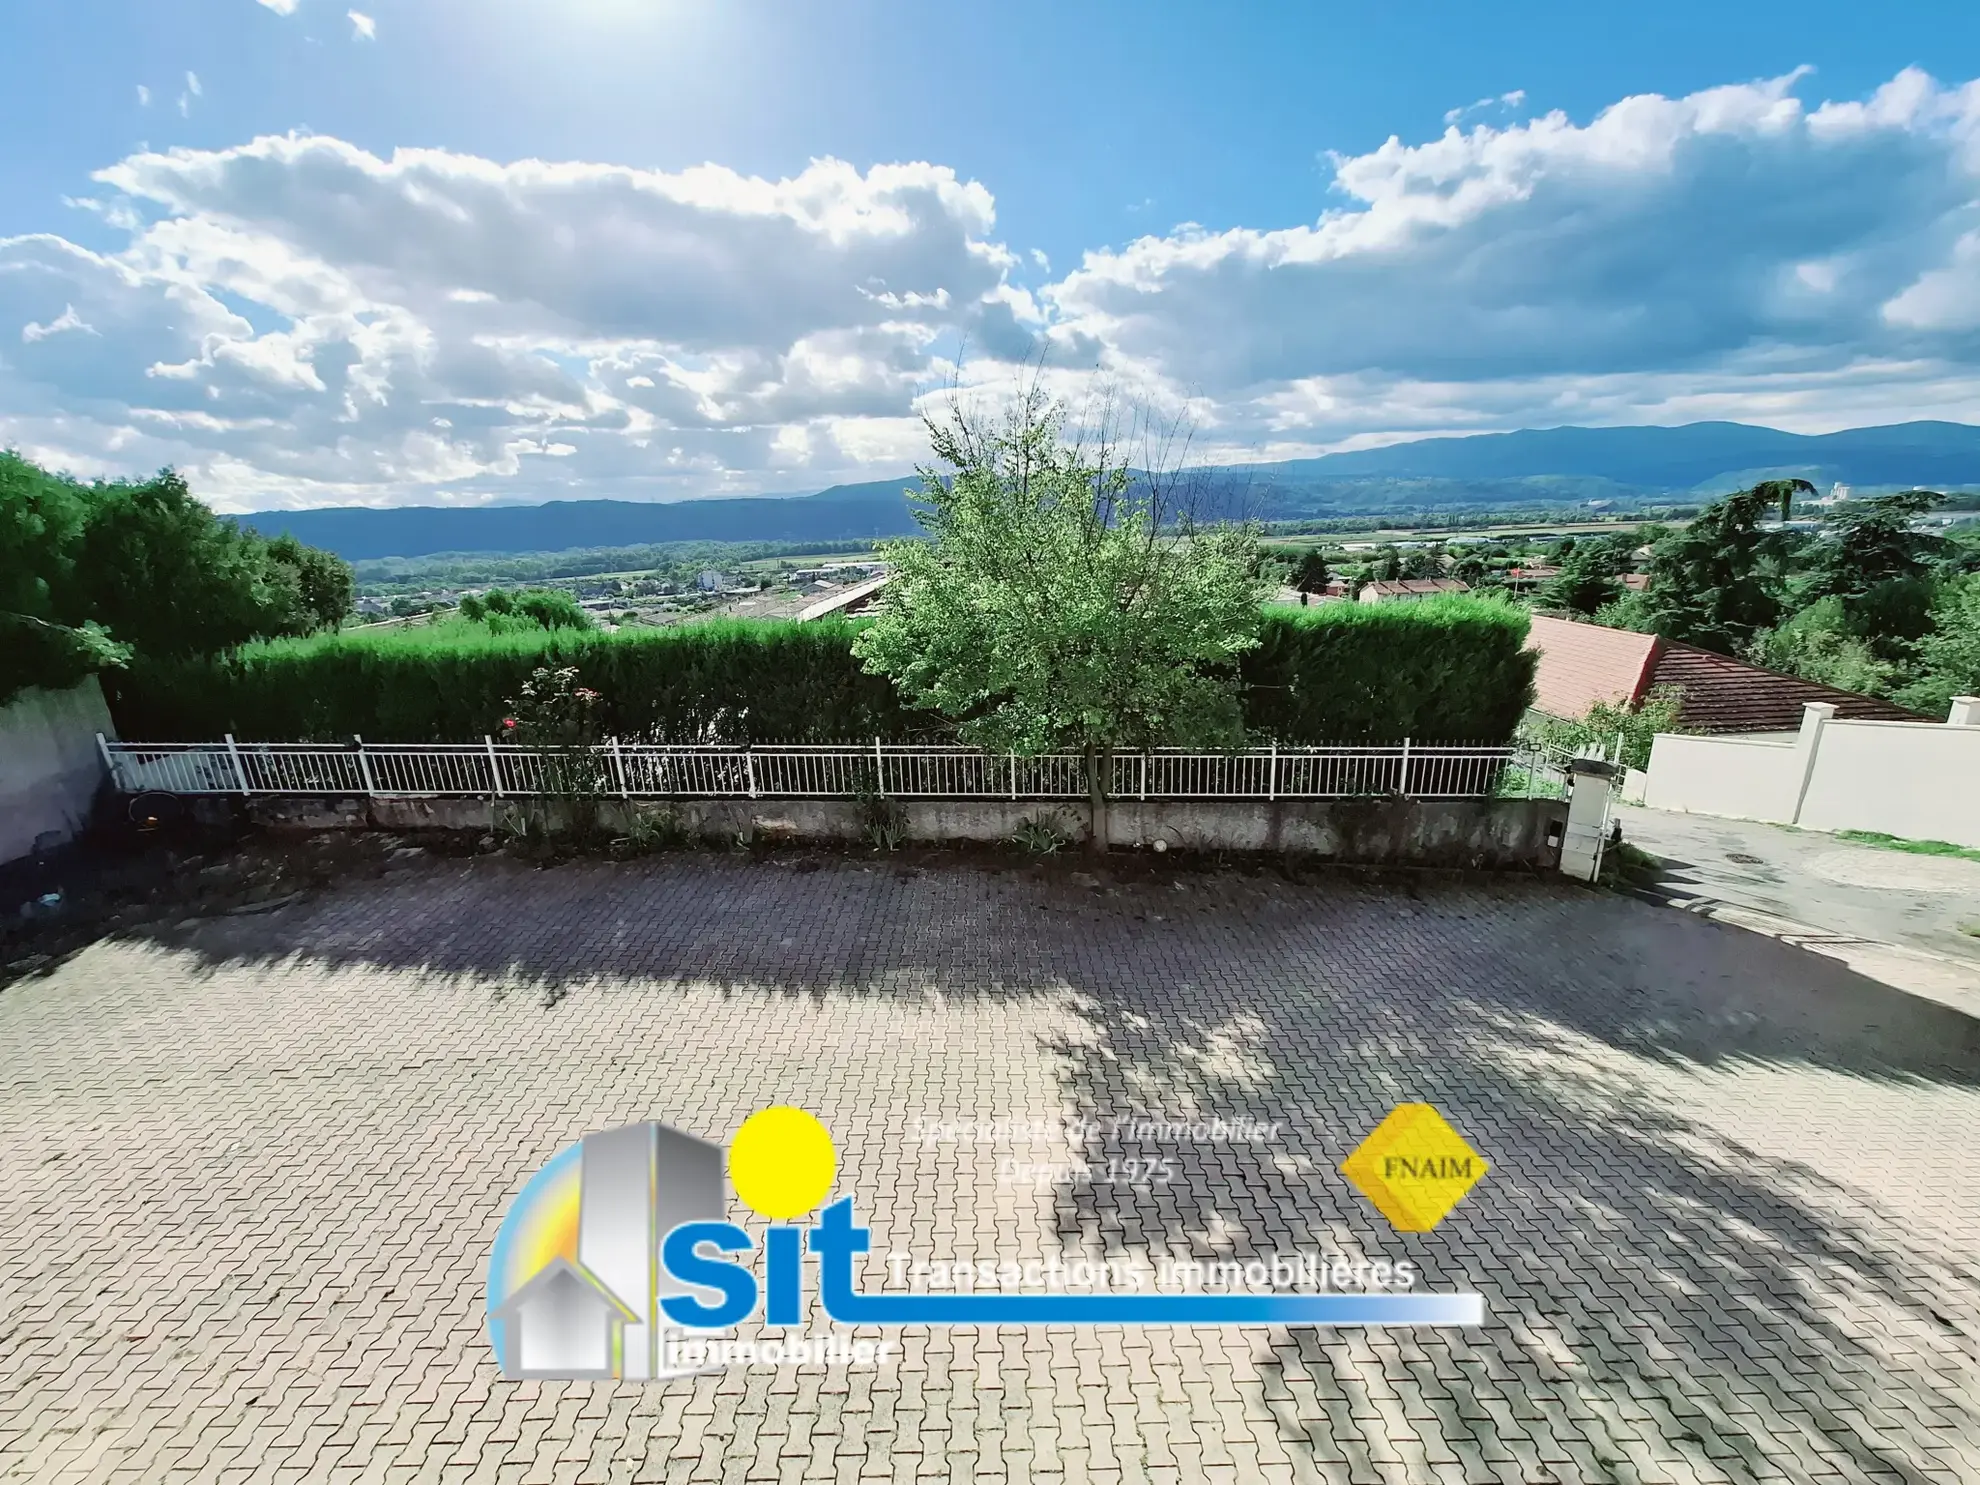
[855,386,1261,849]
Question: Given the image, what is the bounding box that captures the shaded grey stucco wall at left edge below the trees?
[0,675,117,861]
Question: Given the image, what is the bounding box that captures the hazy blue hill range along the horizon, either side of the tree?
[242,422,1980,562]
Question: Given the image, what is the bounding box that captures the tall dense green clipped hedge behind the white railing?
[105,600,1533,743]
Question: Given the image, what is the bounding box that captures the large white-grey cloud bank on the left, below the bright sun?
[0,137,1036,505]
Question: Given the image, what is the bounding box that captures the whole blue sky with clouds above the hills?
[0,0,1980,509]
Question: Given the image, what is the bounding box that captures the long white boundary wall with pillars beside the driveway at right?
[1643,697,1980,847]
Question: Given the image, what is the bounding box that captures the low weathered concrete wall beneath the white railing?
[227,798,1568,869]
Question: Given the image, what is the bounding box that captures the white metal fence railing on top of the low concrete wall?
[97,737,1558,800]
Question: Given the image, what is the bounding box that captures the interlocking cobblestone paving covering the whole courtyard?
[0,857,1980,1483]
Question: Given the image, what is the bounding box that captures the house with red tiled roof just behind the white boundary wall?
[1527,614,1919,733]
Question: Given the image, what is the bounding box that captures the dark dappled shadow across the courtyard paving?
[69,857,1980,1481]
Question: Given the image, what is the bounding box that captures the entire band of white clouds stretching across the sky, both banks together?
[11,71,1980,509]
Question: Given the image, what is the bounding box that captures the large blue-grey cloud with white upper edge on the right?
[1041,71,1980,459]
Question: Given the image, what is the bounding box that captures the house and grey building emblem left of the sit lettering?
[487,1121,727,1380]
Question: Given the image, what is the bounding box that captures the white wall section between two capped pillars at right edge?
[1798,721,1980,849]
